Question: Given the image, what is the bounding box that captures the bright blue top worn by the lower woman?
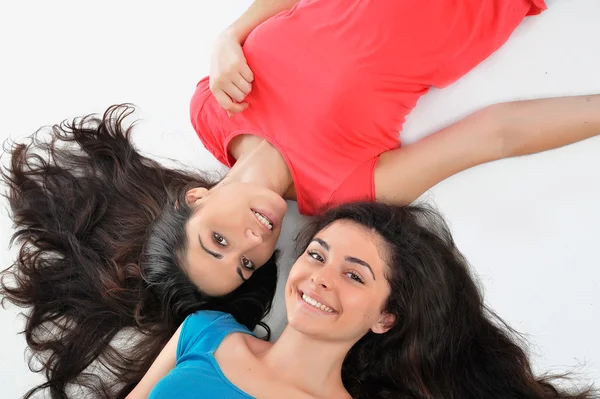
[148,310,254,399]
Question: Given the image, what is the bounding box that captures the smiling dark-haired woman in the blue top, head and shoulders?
[128,203,598,399]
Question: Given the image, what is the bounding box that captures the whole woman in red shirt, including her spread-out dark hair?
[1,0,600,397]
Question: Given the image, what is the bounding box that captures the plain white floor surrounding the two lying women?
[0,0,600,398]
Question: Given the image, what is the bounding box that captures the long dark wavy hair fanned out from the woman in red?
[0,105,277,398]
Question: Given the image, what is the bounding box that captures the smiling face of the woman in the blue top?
[286,221,393,343]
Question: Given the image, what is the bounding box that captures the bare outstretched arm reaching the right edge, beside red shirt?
[375,95,600,204]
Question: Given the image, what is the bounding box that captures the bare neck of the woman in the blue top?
[263,326,352,398]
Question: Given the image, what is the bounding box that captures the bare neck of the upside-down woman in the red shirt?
[217,136,294,199]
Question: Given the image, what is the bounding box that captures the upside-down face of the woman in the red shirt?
[186,183,287,296]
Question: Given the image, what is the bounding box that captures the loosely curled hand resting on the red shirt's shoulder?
[209,32,254,117]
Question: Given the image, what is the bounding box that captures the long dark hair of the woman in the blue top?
[298,203,598,399]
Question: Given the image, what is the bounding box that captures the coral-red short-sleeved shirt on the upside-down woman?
[191,0,545,214]
